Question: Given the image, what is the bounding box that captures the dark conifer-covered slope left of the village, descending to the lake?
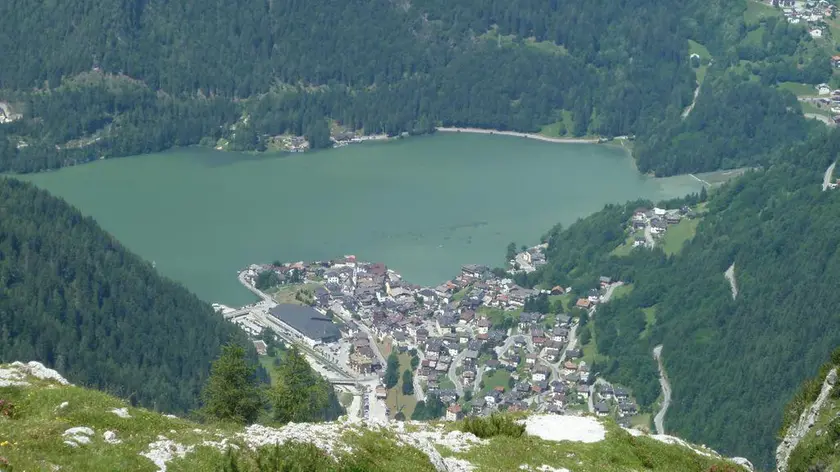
[0,178,244,412]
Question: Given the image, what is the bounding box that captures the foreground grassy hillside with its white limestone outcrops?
[0,363,749,472]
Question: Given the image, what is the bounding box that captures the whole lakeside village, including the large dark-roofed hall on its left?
[220,247,648,426]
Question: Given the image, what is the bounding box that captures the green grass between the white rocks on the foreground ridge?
[0,364,738,472]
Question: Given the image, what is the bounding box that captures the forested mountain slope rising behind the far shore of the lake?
[0,0,744,172]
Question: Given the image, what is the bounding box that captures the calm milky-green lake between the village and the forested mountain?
[23,134,700,306]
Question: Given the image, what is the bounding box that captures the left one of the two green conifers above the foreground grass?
[201,344,262,424]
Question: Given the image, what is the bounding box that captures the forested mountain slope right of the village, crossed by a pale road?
[530,132,840,467]
